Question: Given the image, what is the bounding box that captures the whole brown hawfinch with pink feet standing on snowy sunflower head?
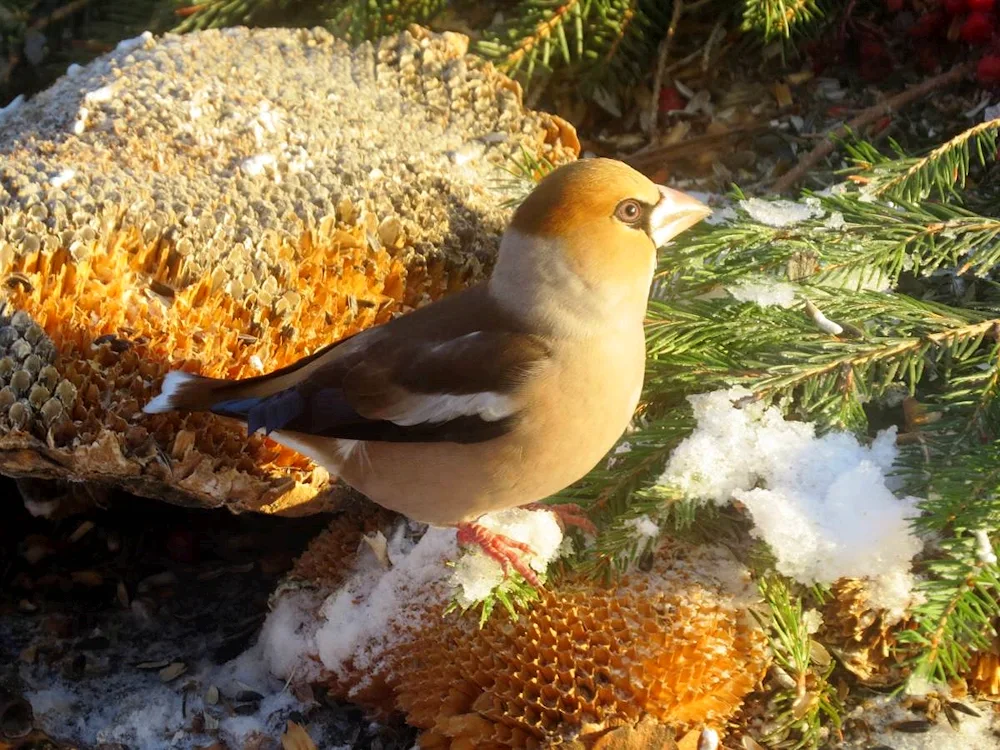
[143,157,710,586]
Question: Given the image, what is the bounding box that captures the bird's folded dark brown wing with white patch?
[229,331,549,443]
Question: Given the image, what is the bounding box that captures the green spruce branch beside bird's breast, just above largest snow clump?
[647,292,1000,428]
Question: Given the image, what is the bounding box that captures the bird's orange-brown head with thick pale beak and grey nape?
[491,159,710,332]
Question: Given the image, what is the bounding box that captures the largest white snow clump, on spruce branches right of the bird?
[659,387,922,618]
